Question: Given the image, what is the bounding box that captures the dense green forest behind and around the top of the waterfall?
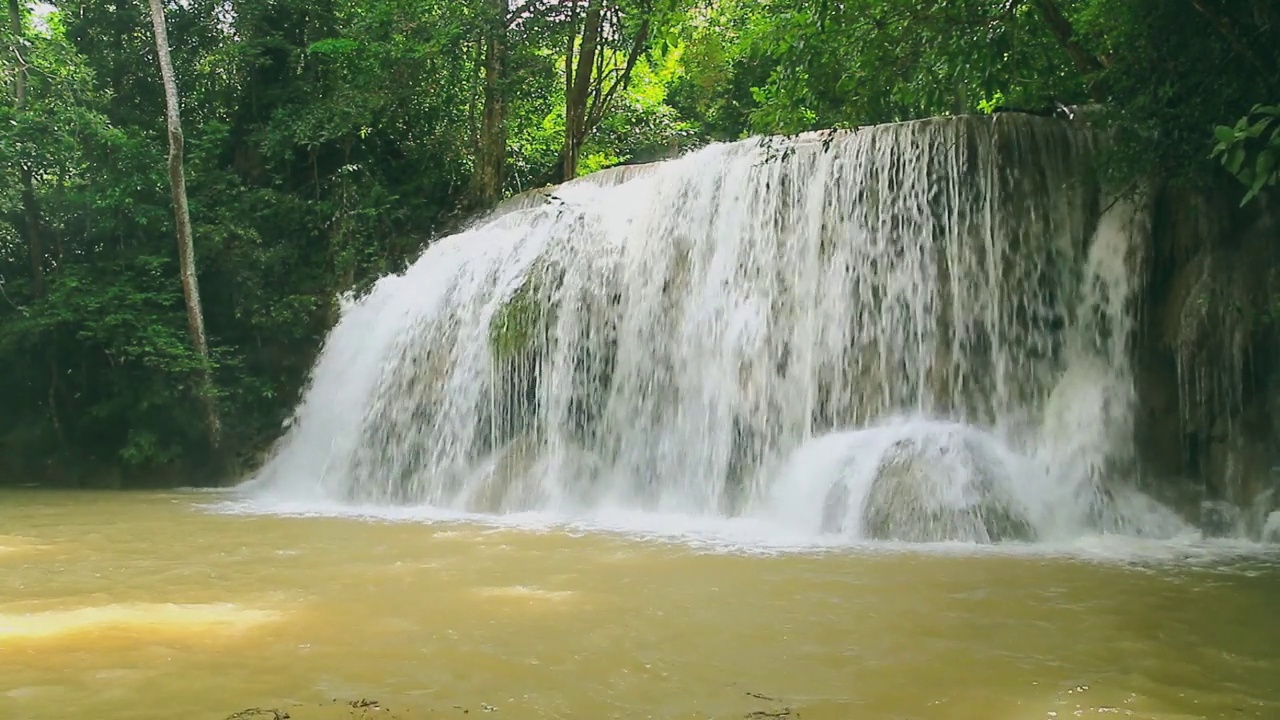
[0,0,1280,484]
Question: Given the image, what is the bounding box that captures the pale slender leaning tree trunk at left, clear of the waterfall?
[147,0,221,451]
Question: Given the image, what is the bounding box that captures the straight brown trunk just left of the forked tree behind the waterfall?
[471,0,507,205]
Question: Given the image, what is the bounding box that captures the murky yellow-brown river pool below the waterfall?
[0,491,1280,720]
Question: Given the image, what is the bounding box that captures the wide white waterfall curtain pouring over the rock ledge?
[250,115,1183,542]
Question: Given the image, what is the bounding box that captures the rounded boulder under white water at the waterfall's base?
[863,439,1036,543]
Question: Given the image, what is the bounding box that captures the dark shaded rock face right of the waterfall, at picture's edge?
[1135,186,1280,539]
